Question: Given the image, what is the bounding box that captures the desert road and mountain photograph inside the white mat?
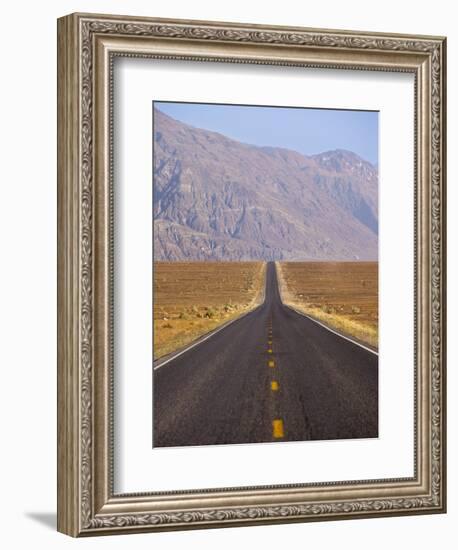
[152,101,379,448]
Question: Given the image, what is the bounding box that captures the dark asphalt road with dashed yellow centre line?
[153,263,378,447]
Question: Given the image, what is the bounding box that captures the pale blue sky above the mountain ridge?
[154,101,378,164]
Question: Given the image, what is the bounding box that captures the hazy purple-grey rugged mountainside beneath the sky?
[153,109,378,261]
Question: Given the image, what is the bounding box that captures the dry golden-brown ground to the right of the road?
[277,262,378,348]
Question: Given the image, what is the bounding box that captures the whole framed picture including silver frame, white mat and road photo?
[58,14,446,536]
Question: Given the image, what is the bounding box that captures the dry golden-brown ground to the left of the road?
[154,262,266,359]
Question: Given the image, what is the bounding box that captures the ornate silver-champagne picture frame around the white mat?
[58,14,446,536]
